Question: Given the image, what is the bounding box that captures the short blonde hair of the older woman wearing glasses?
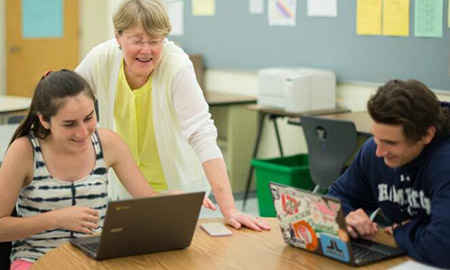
[113,0,172,37]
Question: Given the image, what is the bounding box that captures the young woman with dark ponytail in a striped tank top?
[0,70,162,269]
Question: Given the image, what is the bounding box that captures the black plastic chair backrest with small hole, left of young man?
[301,116,358,192]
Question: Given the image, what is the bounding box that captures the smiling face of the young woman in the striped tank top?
[39,92,97,153]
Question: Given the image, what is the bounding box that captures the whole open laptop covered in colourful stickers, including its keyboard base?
[270,183,406,266]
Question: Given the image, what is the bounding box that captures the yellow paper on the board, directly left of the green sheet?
[383,0,409,36]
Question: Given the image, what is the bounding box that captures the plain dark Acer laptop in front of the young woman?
[70,192,205,260]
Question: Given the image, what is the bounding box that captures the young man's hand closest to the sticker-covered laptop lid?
[345,208,378,240]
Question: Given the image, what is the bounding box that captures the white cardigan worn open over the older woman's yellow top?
[76,39,222,199]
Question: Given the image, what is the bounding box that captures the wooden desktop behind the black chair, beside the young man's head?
[288,112,372,136]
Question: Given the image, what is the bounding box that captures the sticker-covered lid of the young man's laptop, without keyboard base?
[270,183,352,262]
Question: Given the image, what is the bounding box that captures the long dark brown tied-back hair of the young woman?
[9,69,95,144]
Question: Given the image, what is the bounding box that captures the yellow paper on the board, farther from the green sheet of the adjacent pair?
[356,0,382,35]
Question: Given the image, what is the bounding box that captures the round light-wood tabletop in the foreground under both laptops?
[31,218,409,270]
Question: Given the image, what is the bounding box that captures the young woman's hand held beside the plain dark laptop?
[52,206,98,234]
